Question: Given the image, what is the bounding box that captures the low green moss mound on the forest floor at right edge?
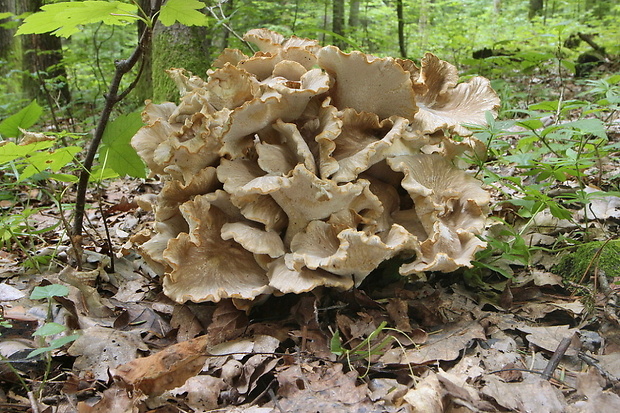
[552,240,620,281]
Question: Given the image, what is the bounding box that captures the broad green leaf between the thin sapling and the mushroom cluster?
[99,112,146,178]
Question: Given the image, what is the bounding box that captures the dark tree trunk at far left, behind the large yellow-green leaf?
[17,0,71,105]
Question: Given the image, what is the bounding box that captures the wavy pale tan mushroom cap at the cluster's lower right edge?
[387,154,489,274]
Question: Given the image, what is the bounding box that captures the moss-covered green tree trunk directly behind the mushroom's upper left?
[152,22,209,102]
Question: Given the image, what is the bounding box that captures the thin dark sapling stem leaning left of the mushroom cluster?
[72,0,162,258]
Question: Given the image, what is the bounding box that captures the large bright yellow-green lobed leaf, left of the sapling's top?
[16,1,138,37]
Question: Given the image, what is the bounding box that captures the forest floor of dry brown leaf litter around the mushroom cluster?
[0,72,620,413]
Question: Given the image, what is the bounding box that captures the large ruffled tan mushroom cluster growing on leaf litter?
[132,29,499,303]
